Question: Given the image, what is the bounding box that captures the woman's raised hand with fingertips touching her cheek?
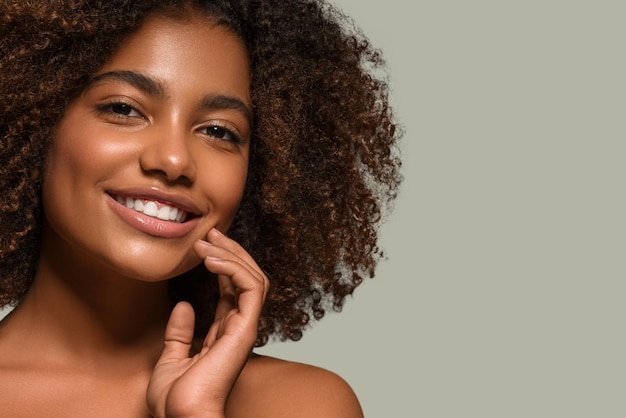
[147,229,269,418]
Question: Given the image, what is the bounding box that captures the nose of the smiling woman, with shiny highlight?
[139,126,196,182]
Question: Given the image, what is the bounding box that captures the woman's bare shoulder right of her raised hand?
[226,356,363,418]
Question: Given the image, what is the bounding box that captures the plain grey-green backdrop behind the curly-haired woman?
[1,0,626,418]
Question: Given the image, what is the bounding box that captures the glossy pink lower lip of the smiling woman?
[108,196,199,238]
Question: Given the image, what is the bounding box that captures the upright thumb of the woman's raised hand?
[159,302,195,362]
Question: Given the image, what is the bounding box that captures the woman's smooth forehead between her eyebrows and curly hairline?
[98,15,250,101]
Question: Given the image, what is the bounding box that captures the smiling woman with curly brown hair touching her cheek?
[0,0,399,417]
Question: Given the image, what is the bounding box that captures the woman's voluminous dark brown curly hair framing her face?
[0,0,401,346]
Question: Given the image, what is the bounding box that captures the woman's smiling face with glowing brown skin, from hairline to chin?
[43,13,251,280]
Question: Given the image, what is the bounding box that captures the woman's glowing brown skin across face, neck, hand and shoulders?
[0,11,363,418]
